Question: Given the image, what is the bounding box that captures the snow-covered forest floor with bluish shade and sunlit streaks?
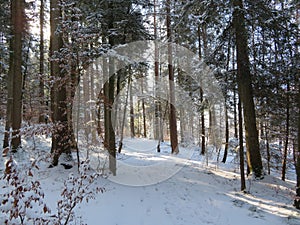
[0,130,300,225]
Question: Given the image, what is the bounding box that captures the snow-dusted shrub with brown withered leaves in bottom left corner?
[0,157,50,224]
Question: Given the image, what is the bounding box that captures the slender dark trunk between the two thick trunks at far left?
[39,0,47,123]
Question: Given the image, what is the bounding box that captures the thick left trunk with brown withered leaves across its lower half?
[50,0,77,167]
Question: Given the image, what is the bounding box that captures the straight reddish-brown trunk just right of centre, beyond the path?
[166,0,179,154]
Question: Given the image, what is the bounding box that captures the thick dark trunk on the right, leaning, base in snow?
[233,0,263,178]
